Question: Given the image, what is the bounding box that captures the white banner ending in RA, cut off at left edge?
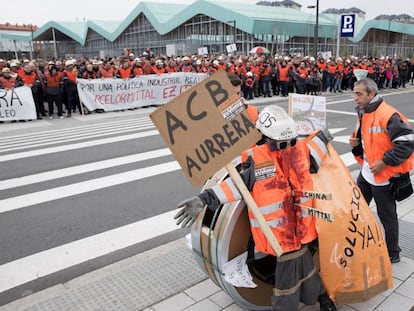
[0,86,37,121]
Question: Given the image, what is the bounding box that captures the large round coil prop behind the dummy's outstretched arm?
[191,159,292,310]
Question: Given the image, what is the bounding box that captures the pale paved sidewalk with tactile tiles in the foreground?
[0,171,414,311]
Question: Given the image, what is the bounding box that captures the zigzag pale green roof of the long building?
[2,0,414,45]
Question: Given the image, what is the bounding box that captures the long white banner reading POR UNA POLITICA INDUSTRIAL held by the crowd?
[78,72,207,111]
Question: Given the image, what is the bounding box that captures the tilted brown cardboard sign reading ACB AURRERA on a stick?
[150,70,261,187]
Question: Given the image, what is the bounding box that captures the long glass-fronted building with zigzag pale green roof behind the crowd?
[0,0,414,59]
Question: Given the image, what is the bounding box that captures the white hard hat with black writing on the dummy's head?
[256,105,297,140]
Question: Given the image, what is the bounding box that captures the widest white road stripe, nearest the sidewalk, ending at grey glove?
[0,210,179,292]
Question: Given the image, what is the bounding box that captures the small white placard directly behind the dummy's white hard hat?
[289,94,326,135]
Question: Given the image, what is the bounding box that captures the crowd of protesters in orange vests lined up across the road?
[0,49,414,119]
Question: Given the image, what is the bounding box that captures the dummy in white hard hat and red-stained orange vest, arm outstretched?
[174,105,336,311]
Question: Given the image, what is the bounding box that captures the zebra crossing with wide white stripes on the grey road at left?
[0,116,353,305]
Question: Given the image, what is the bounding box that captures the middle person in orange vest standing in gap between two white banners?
[44,65,63,119]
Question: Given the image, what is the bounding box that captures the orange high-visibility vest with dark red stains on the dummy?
[211,141,317,255]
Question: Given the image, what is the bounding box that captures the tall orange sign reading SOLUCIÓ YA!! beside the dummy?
[312,144,392,305]
